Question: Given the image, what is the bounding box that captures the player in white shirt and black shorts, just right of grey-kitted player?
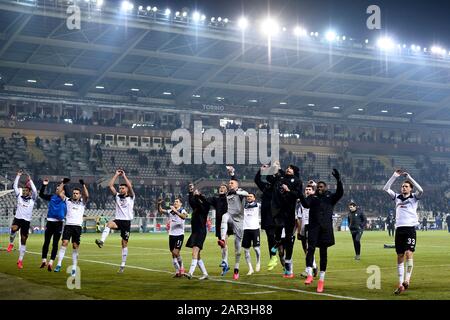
[242,193,261,276]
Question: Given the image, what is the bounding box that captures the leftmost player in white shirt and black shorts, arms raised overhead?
[7,170,37,269]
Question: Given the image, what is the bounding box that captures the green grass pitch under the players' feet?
[0,231,450,300]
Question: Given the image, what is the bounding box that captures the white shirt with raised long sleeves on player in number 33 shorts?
[383,172,423,228]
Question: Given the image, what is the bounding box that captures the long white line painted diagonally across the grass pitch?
[22,251,366,300]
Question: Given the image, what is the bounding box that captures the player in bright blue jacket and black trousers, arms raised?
[39,178,70,272]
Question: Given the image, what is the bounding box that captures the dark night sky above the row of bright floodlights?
[106,0,450,48]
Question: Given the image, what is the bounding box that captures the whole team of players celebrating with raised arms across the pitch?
[7,162,423,294]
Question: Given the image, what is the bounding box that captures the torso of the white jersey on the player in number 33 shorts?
[393,193,419,228]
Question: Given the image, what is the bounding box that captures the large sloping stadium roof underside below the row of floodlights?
[0,1,450,121]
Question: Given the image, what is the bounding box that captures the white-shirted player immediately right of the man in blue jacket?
[55,180,89,276]
